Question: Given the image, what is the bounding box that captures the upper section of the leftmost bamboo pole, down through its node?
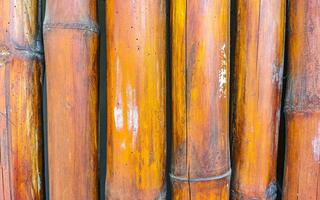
[0,0,42,66]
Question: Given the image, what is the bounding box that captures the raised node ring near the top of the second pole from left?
[43,23,99,33]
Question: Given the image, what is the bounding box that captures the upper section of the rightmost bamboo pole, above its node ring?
[285,0,320,113]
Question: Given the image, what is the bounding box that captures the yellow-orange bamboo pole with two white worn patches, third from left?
[106,0,166,199]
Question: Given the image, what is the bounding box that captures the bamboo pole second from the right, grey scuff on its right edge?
[232,0,285,199]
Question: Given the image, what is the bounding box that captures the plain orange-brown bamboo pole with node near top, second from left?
[44,0,98,200]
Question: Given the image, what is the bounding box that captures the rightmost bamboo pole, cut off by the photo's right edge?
[283,0,320,199]
